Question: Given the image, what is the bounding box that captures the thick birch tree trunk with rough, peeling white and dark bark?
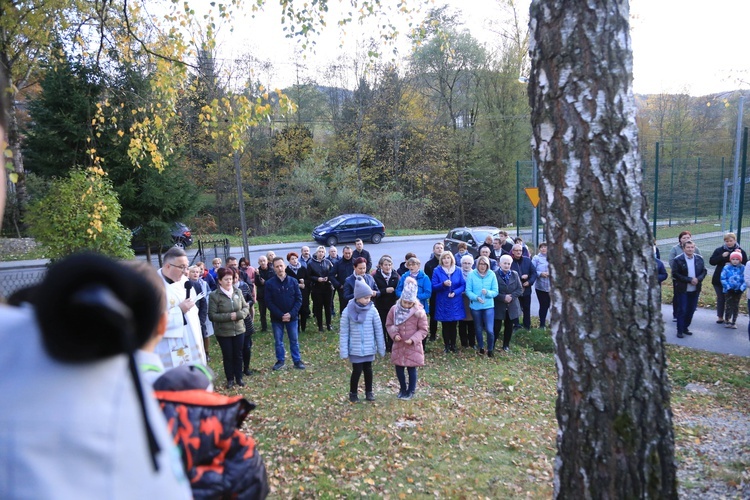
[529,0,677,500]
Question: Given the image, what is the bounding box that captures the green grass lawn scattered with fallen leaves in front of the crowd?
[211,318,750,498]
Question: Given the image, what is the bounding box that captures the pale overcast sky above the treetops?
[198,0,750,95]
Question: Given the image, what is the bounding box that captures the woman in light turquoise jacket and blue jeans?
[464,256,497,357]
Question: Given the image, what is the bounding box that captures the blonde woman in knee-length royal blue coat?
[432,252,466,352]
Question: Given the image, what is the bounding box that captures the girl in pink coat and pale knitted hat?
[385,277,430,399]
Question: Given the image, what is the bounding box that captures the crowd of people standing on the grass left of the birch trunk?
[173,236,550,401]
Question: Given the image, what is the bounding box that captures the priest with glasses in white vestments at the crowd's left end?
[154,247,206,369]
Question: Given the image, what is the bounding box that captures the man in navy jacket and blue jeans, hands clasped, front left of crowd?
[266,257,305,370]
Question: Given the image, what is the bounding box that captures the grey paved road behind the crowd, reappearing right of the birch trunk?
[0,234,750,357]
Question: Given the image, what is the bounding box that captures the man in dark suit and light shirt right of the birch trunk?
[672,240,707,338]
